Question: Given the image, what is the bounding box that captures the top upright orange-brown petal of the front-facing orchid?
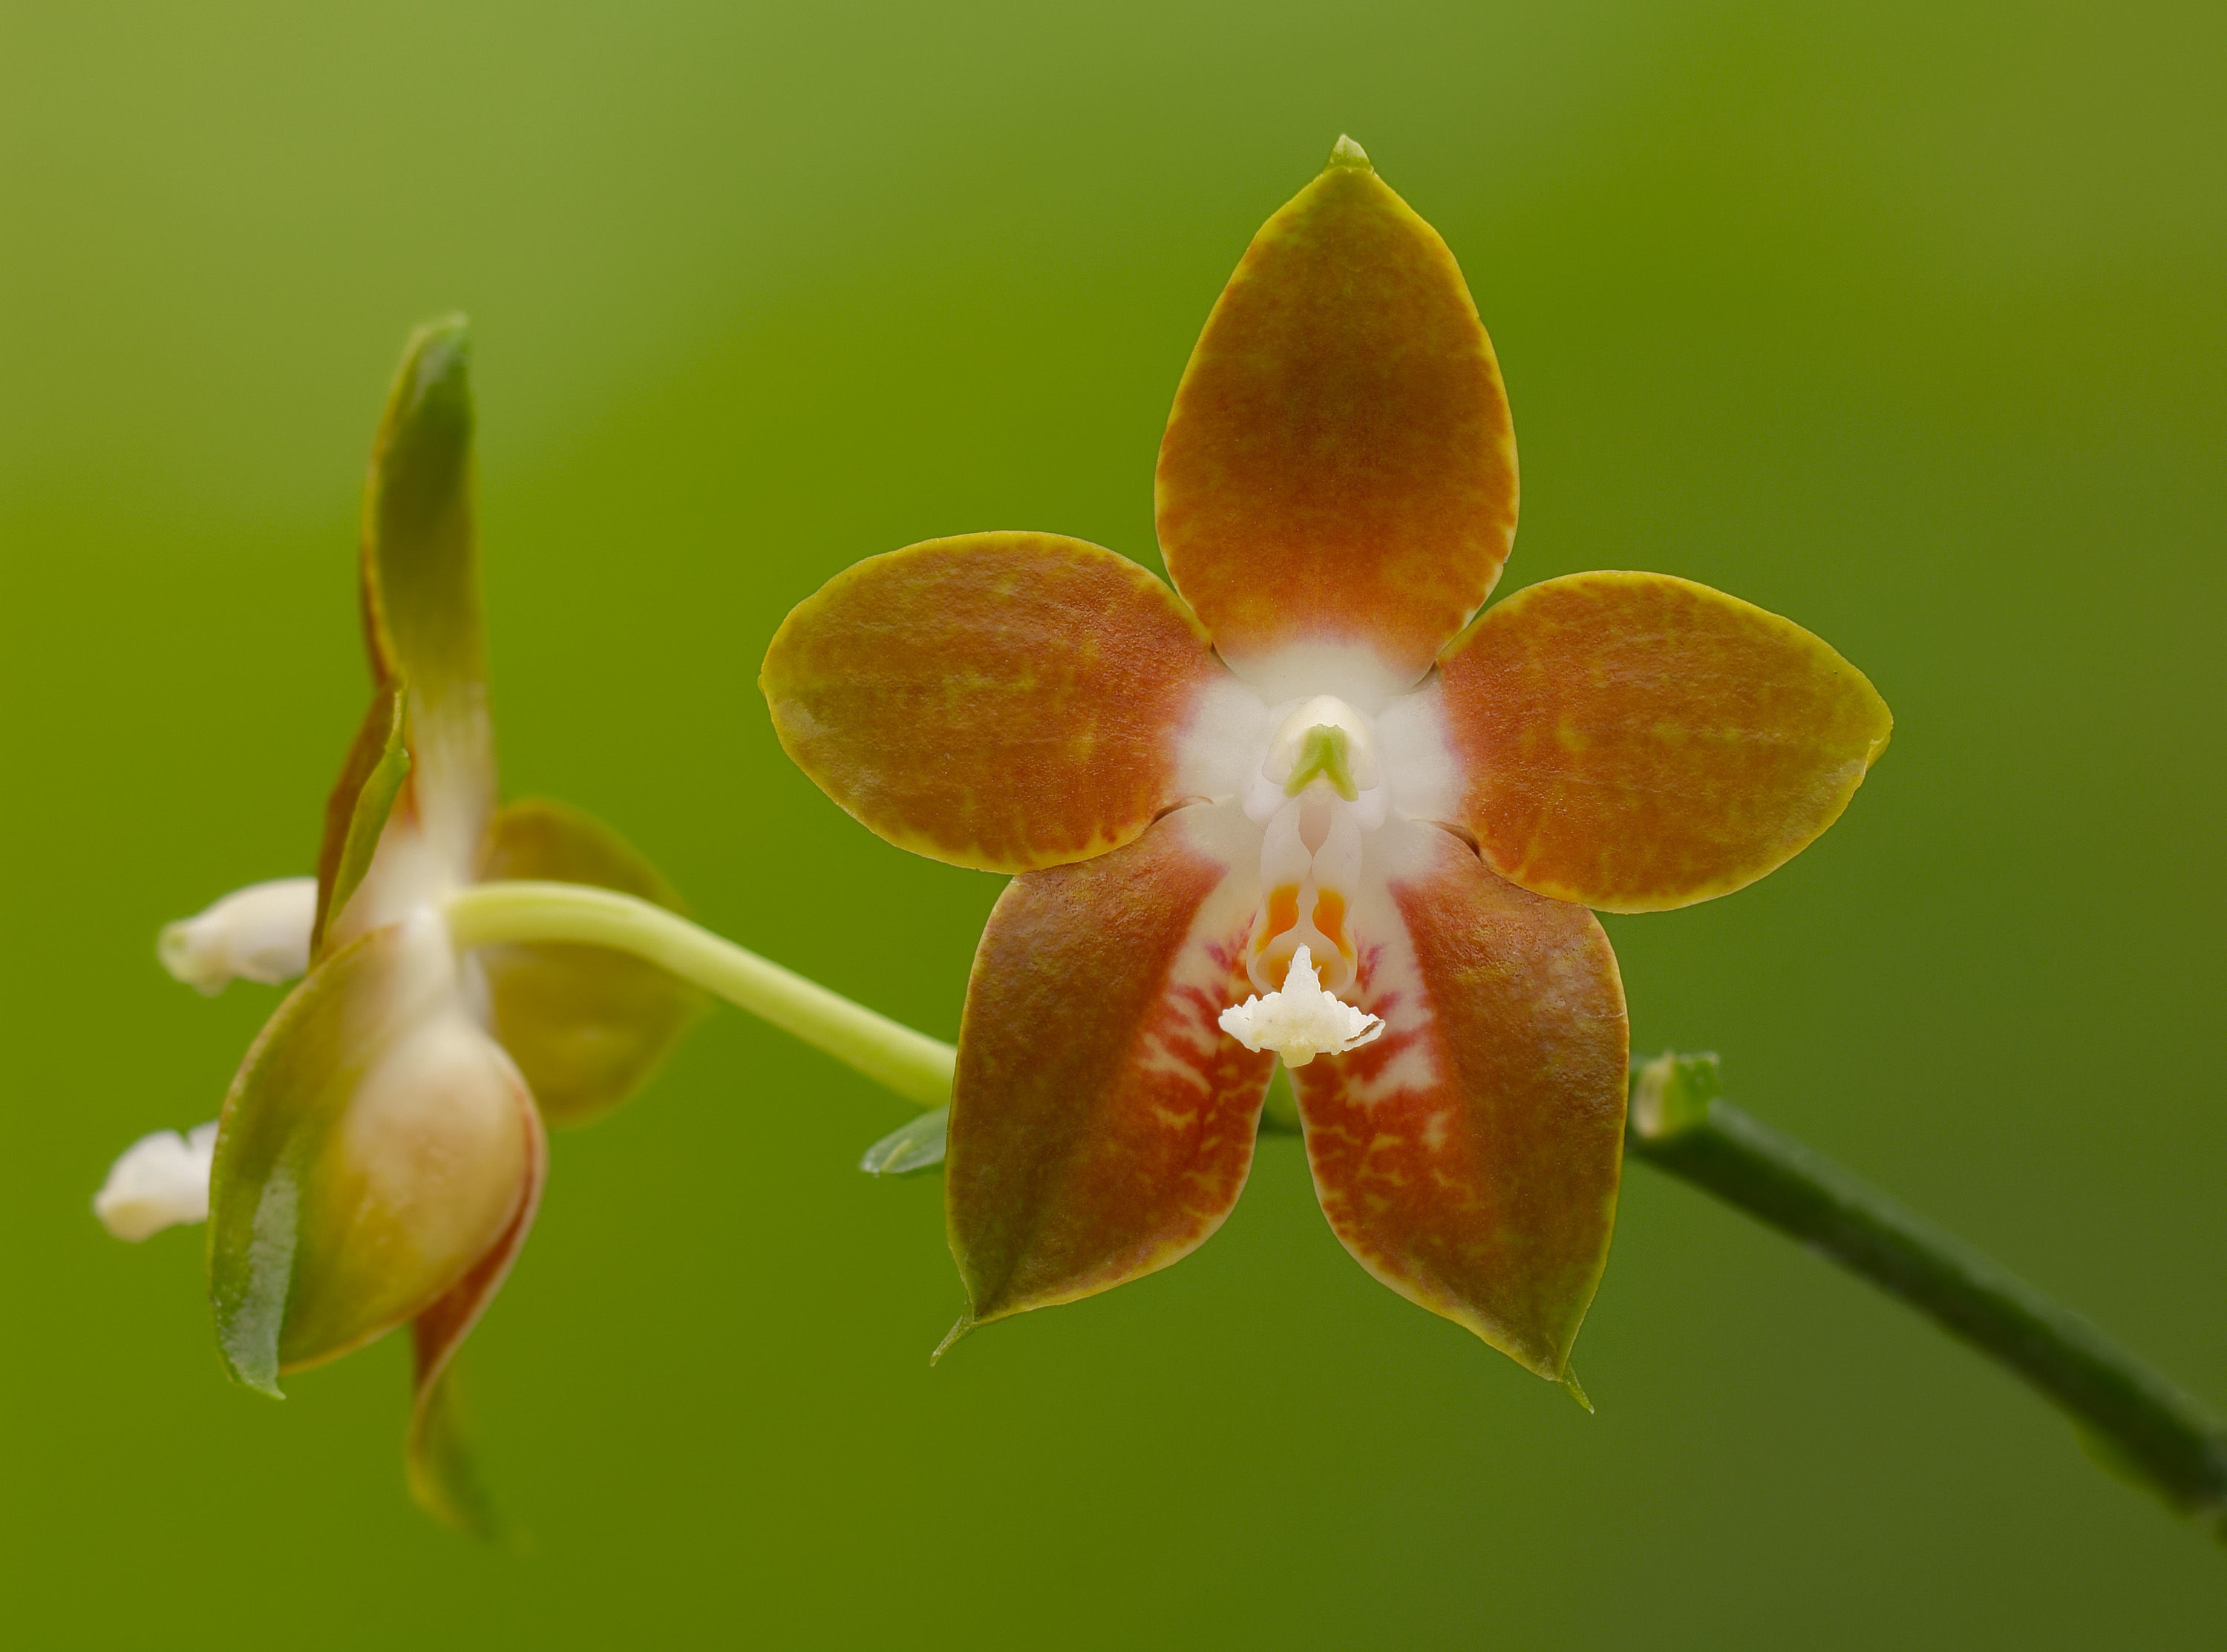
[1158,140,1517,692]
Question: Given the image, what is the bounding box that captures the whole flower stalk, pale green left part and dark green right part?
[448,882,2227,1534]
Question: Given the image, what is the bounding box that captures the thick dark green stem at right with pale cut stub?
[1626,1055,2227,1521]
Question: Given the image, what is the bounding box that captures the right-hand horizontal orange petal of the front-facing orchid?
[1434,572,1895,913]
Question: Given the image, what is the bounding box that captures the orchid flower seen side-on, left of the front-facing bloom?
[96,321,699,1527]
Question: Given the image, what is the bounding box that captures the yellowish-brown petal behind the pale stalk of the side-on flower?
[479,797,706,1124]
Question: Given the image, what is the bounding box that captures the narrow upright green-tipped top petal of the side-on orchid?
[363,316,494,871]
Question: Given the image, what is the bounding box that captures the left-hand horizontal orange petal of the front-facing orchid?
[759,534,1225,873]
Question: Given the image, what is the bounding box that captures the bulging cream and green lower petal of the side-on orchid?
[209,913,541,1394]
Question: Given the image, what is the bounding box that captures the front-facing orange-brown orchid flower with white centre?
[762,140,1891,1380]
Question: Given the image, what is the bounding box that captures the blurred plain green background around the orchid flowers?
[0,0,2227,1650]
